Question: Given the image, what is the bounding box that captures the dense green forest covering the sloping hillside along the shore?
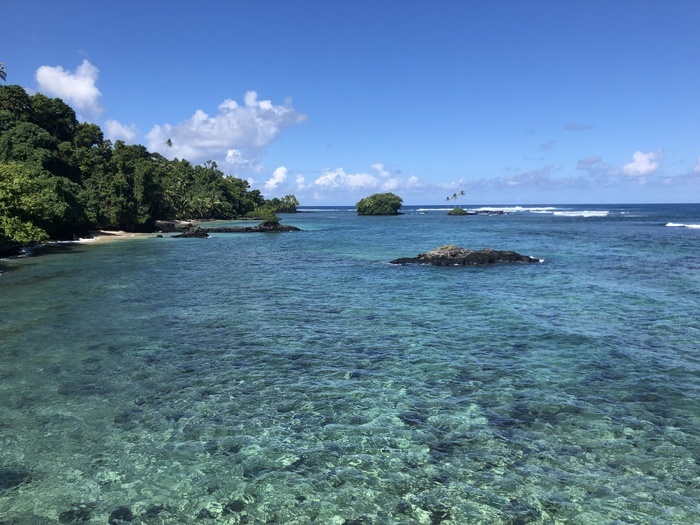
[0,86,292,244]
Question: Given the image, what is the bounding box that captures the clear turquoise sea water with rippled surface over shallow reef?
[0,205,700,525]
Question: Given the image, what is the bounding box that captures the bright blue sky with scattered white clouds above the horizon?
[0,0,700,206]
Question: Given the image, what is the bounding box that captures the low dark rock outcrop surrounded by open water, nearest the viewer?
[391,244,542,266]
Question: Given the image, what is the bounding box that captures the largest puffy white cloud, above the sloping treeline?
[146,91,306,167]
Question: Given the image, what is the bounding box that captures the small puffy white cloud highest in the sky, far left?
[34,60,103,116]
